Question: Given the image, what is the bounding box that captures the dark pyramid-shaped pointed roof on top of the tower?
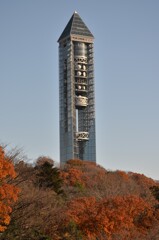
[58,11,94,42]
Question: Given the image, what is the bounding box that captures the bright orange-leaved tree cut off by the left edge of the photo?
[0,147,19,232]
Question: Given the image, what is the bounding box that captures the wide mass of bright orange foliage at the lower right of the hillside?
[66,196,155,240]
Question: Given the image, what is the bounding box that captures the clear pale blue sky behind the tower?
[0,0,159,179]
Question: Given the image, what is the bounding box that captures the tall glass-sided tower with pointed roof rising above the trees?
[58,12,96,163]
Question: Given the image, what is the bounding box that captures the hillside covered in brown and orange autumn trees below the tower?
[0,157,159,240]
